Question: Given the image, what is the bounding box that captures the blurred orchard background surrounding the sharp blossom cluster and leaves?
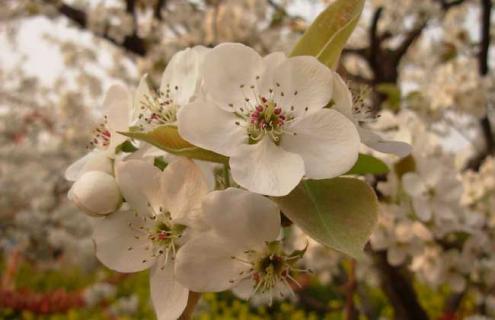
[0,0,495,320]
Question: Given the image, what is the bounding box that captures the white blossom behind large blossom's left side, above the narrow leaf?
[132,46,209,130]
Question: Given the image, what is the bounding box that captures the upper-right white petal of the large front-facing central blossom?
[270,56,333,115]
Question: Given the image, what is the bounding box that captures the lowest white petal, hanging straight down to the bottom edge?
[150,260,189,320]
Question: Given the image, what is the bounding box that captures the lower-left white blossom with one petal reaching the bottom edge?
[93,158,207,320]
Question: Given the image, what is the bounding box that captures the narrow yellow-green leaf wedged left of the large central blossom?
[120,125,229,164]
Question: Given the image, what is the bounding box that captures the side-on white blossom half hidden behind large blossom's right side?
[333,73,411,157]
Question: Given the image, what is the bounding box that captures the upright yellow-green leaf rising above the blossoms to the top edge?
[290,0,364,69]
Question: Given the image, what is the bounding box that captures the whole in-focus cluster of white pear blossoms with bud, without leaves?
[66,43,409,319]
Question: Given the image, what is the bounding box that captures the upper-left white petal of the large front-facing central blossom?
[203,43,263,110]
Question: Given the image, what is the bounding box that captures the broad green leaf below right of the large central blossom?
[273,178,378,259]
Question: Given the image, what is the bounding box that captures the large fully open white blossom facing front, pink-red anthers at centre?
[178,43,359,196]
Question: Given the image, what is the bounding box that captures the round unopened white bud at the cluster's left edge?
[68,171,122,216]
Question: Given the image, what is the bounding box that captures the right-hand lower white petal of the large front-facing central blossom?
[280,109,360,179]
